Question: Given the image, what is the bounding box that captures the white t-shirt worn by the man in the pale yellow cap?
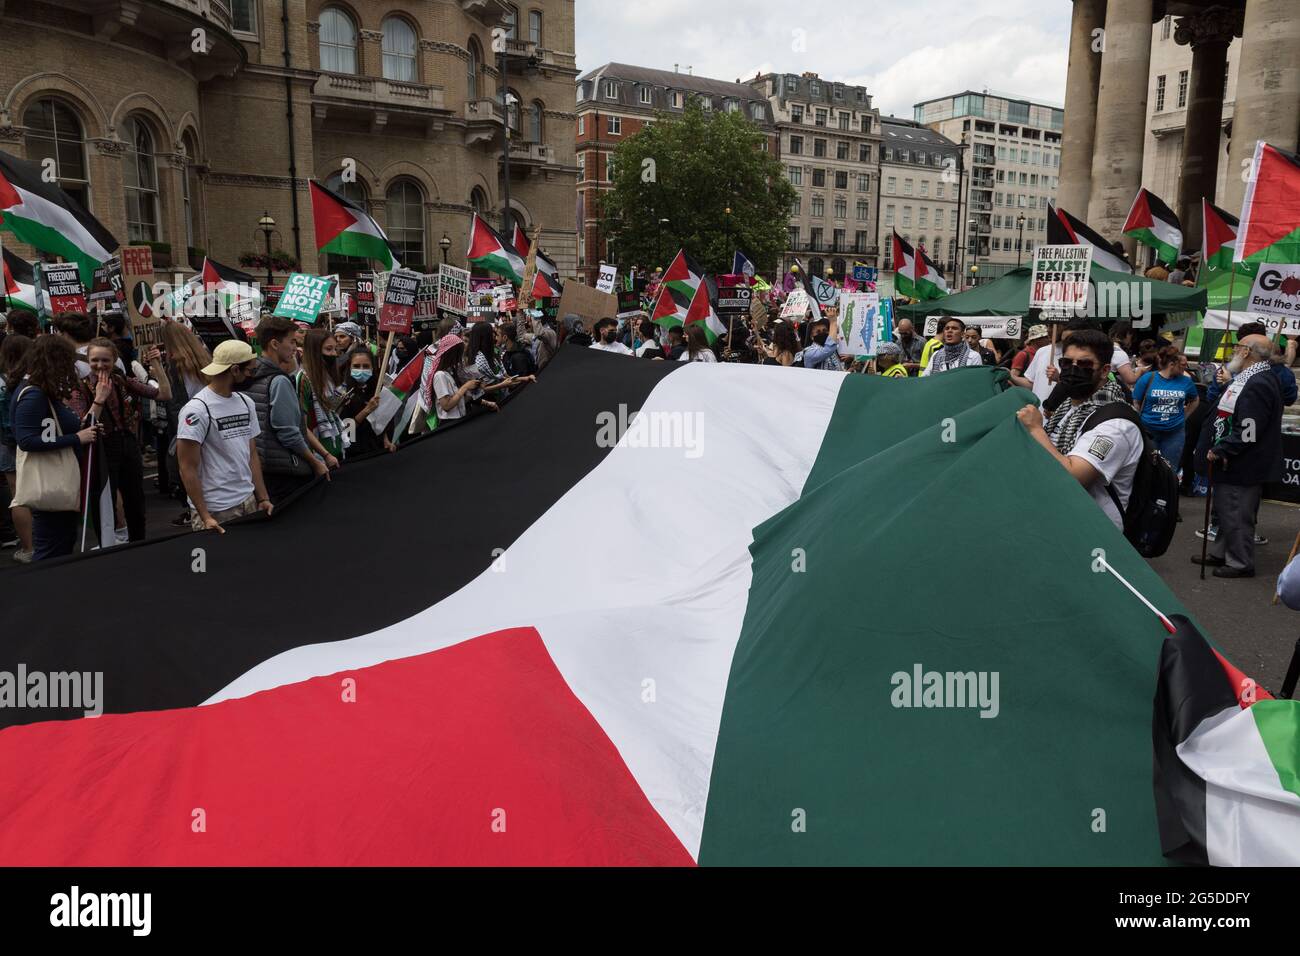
[176,388,261,514]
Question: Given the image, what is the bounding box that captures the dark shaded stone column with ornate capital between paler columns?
[1161,7,1242,257]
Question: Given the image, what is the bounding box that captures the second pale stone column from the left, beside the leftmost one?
[1088,0,1152,255]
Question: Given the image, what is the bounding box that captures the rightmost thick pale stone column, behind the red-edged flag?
[1223,0,1300,216]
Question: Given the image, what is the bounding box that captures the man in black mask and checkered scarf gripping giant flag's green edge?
[1017,329,1143,531]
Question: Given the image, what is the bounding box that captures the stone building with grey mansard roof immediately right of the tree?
[749,73,883,280]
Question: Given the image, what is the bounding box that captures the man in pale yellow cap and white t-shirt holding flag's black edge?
[176,339,272,535]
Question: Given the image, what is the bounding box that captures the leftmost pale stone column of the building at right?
[1057,0,1106,216]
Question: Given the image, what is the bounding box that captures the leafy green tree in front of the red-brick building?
[602,96,796,273]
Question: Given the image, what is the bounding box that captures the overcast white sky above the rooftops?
[577,0,1071,117]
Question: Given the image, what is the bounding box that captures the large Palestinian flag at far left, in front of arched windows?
[0,152,117,289]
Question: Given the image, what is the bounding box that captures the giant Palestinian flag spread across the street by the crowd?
[0,347,1300,865]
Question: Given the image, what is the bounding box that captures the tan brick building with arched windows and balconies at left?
[0,0,577,283]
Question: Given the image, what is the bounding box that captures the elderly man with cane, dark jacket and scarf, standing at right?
[1192,334,1283,578]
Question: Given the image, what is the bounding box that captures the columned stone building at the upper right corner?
[1061,0,1300,254]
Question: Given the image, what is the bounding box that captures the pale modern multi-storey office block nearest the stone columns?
[914,90,1063,287]
